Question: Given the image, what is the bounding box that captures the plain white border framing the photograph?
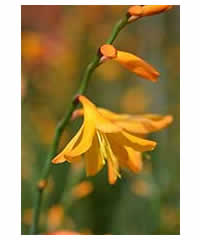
[0,0,200,240]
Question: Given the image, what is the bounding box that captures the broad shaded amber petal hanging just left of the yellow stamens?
[85,135,105,176]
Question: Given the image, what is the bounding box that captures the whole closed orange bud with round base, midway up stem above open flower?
[100,44,160,82]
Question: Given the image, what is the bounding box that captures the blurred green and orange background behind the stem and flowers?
[21,5,180,235]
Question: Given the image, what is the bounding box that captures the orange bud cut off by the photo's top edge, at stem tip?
[128,5,172,22]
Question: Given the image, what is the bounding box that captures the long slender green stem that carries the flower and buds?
[30,11,128,234]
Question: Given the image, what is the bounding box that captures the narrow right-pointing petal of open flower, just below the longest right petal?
[107,131,156,152]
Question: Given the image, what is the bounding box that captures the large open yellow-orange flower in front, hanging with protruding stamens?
[52,96,159,184]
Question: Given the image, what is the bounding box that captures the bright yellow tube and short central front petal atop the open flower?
[78,96,121,133]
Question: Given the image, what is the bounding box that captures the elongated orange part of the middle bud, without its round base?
[113,51,160,82]
